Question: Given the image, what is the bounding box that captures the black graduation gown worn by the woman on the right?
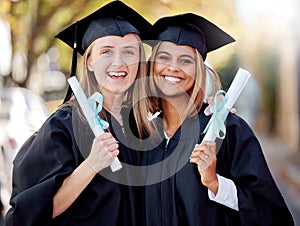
[143,105,294,226]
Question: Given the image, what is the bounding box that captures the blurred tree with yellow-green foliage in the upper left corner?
[5,0,92,87]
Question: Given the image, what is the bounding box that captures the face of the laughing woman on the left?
[86,34,141,97]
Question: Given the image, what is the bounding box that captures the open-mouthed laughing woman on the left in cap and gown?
[5,1,150,226]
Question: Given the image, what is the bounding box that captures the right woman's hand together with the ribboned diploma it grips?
[190,68,250,192]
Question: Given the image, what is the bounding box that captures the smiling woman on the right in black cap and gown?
[137,13,294,226]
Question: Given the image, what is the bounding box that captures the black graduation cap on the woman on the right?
[146,13,235,60]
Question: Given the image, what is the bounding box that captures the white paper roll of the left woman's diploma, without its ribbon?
[68,76,122,172]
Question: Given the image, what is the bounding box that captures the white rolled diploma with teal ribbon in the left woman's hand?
[68,77,122,172]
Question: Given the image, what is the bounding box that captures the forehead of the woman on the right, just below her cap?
[158,41,195,55]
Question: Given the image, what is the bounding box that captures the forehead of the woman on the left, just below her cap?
[93,33,140,48]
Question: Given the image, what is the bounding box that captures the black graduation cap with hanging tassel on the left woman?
[55,1,151,103]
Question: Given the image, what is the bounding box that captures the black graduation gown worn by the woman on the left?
[5,107,138,226]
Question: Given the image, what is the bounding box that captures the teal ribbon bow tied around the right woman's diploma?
[203,90,230,139]
